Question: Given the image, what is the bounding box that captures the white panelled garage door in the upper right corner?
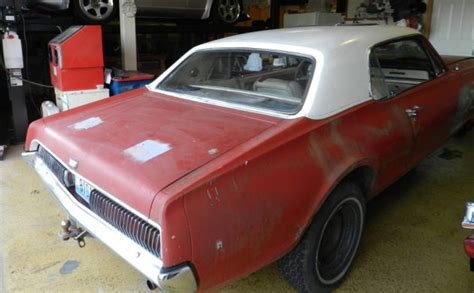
[430,0,474,56]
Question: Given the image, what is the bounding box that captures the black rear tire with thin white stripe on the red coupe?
[279,181,365,292]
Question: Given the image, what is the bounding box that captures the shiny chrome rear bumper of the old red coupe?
[22,152,197,292]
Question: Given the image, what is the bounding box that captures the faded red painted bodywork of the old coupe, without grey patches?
[27,55,474,289]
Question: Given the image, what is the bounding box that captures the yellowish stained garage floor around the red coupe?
[0,132,474,292]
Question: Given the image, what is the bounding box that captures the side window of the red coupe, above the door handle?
[370,38,438,99]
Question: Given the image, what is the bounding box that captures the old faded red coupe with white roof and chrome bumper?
[24,26,474,292]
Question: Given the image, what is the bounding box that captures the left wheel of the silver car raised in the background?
[72,0,118,24]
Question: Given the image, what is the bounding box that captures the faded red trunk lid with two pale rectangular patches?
[40,90,279,216]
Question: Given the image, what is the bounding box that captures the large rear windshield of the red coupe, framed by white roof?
[158,49,315,114]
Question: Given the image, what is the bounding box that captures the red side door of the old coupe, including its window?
[372,36,459,166]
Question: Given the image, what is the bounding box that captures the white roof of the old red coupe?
[149,25,419,119]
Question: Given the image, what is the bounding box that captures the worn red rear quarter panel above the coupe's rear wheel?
[158,97,418,289]
